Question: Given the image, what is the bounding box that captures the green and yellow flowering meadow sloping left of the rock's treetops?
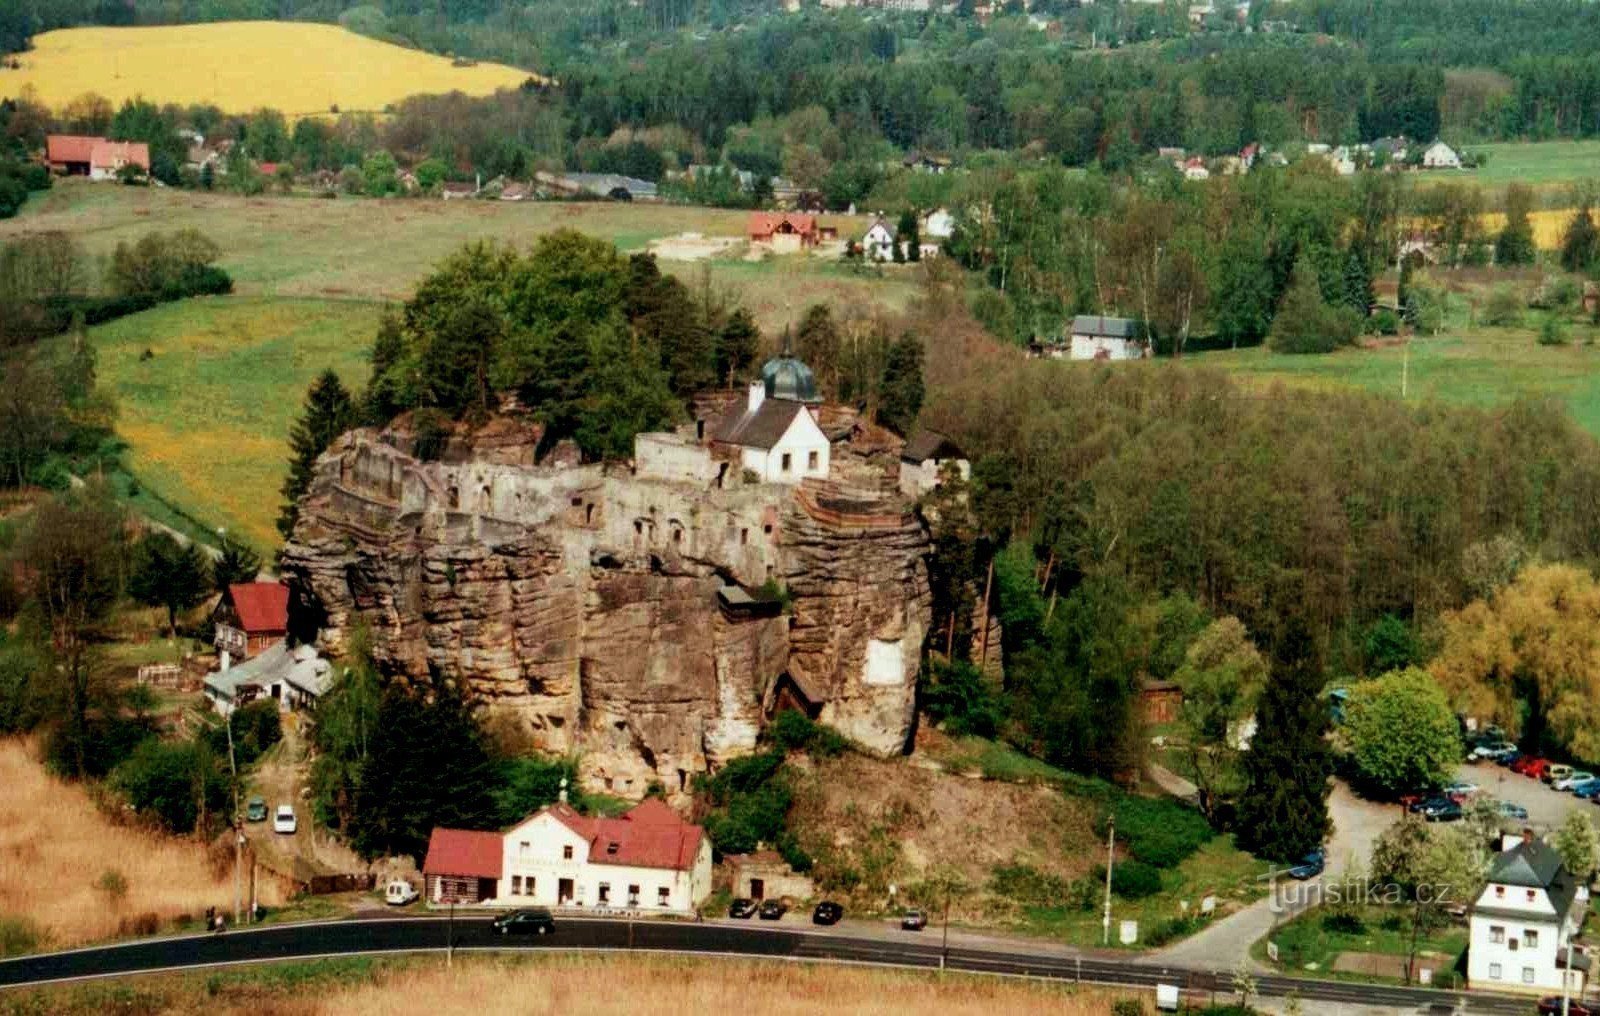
[90,296,381,550]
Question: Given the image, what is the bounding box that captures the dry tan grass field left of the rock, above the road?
[0,739,278,947]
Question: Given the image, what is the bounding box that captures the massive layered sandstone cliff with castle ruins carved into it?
[282,421,930,797]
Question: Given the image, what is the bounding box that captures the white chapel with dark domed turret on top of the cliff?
[712,339,830,483]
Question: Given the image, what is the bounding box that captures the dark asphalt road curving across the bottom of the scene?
[0,917,1533,1014]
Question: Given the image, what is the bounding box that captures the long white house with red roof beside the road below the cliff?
[422,797,710,914]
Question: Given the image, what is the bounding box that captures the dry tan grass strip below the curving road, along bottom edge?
[0,954,1147,1016]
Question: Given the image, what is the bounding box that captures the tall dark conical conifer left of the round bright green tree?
[1237,619,1333,861]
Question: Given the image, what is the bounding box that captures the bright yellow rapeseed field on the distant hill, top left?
[0,21,536,117]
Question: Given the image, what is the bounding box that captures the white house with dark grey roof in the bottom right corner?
[1467,830,1589,998]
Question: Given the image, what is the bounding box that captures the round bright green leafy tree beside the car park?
[1342,667,1461,794]
